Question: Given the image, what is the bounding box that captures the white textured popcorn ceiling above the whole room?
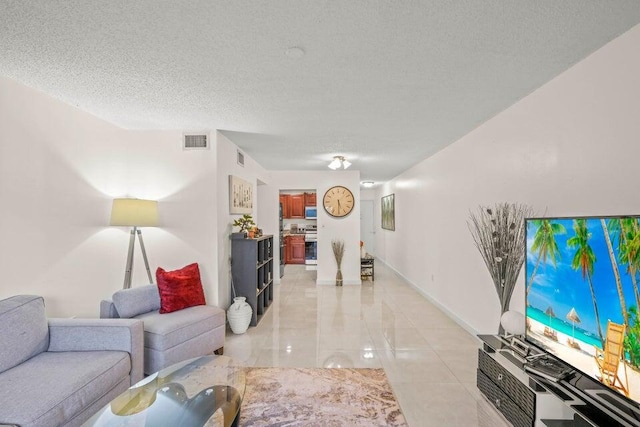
[0,0,640,181]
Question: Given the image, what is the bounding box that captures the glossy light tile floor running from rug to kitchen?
[224,263,508,427]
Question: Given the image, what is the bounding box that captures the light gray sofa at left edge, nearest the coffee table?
[0,295,143,427]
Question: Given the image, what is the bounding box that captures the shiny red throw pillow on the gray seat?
[156,263,205,313]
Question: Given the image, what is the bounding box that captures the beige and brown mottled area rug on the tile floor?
[240,368,407,427]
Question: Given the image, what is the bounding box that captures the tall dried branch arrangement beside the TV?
[467,203,533,334]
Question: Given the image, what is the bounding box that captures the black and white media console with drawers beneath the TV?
[477,335,640,427]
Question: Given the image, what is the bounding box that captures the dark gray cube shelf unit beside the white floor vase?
[231,235,275,326]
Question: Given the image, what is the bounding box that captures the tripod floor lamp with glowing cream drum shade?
[110,199,158,289]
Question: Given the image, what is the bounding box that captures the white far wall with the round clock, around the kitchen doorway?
[258,170,361,285]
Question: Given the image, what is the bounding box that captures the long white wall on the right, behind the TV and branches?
[376,26,640,333]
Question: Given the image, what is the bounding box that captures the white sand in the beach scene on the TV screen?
[527,318,640,401]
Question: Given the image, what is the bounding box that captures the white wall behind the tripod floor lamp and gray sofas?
[0,77,218,317]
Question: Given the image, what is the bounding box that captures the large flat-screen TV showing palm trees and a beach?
[525,217,640,401]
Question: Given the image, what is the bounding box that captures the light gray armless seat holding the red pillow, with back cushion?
[100,284,226,375]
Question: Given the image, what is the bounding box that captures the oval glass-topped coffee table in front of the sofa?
[84,356,245,427]
